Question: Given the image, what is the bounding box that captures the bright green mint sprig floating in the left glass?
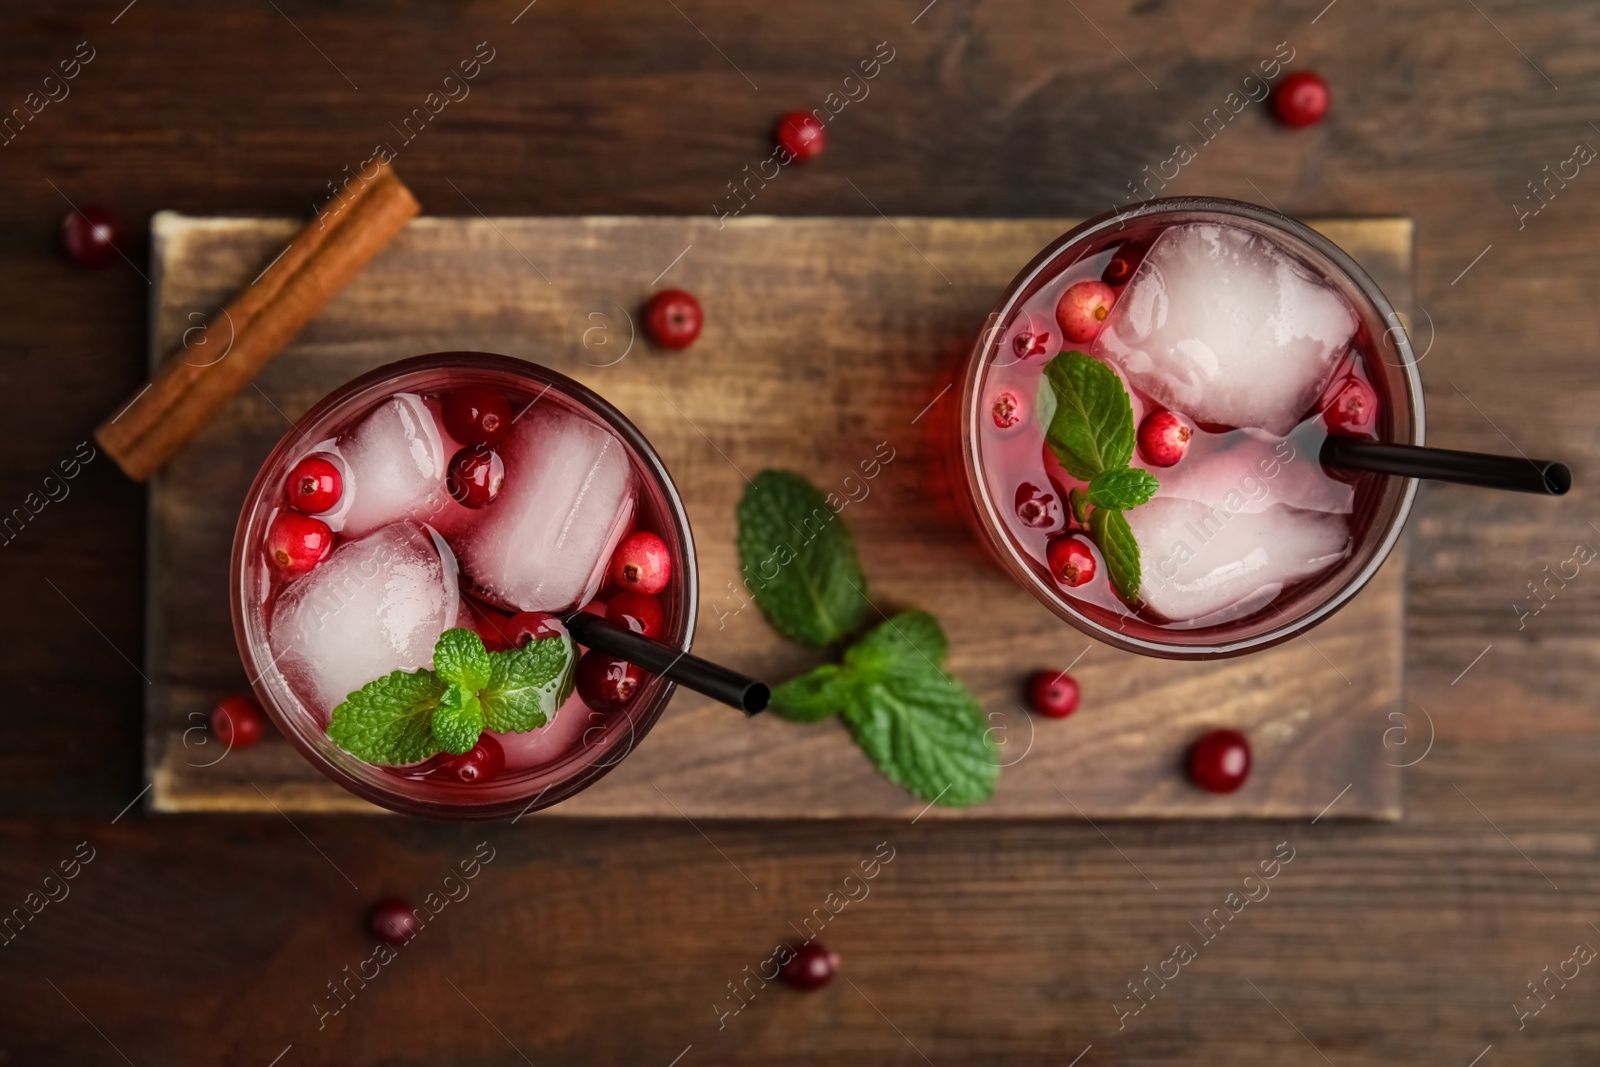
[328,629,574,766]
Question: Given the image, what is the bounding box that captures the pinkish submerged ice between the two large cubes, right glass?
[1152,430,1355,515]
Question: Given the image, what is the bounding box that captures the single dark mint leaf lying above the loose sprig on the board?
[738,470,867,645]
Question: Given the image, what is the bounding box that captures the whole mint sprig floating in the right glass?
[1045,350,1162,603]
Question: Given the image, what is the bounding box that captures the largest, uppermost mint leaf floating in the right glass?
[1045,350,1134,482]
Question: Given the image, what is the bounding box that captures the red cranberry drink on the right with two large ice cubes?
[960,198,1422,657]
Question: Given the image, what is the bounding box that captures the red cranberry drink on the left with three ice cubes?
[232,352,696,817]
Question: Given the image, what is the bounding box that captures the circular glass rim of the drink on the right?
[958,197,1427,659]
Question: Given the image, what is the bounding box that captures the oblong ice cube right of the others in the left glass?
[458,403,635,611]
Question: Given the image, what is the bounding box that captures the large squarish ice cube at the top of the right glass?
[1094,222,1358,435]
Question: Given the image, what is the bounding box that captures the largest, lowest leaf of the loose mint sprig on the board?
[845,668,1000,808]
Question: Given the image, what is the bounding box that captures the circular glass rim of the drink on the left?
[229,350,699,821]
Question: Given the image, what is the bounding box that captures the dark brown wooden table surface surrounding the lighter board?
[0,0,1600,1067]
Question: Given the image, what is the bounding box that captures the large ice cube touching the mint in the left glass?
[269,523,459,715]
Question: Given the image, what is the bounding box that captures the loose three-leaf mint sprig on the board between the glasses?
[771,611,1000,808]
